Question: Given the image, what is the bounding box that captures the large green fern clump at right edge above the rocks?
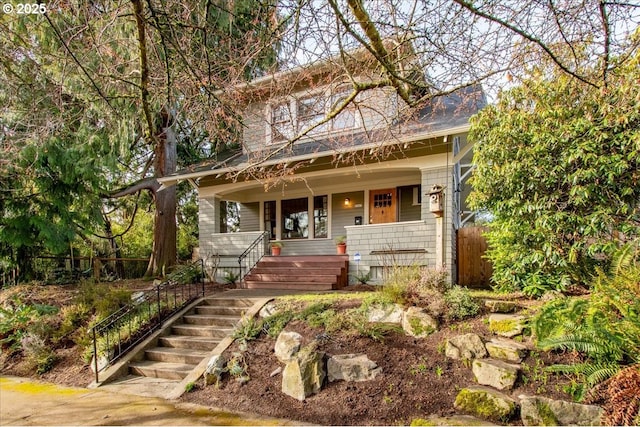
[532,244,640,397]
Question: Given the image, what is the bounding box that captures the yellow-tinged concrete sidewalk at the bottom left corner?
[0,376,300,426]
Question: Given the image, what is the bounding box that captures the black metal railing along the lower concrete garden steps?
[90,259,205,383]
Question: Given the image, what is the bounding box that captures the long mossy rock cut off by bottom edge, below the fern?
[519,395,604,426]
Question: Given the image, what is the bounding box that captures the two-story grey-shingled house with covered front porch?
[160,45,485,289]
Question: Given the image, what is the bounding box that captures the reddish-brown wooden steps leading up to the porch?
[244,255,349,290]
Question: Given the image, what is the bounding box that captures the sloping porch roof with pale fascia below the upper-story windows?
[158,86,486,189]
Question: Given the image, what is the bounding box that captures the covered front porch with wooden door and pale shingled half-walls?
[199,152,454,283]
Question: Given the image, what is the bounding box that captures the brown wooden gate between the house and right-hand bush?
[456,227,493,288]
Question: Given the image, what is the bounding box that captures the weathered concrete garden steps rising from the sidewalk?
[129,298,253,382]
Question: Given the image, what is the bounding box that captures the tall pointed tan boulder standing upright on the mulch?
[282,341,326,401]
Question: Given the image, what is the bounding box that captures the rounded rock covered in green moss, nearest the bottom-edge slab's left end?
[453,387,517,423]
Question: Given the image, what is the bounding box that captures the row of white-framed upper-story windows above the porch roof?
[267,88,357,144]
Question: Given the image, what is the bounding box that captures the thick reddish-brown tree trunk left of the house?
[145,117,177,276]
